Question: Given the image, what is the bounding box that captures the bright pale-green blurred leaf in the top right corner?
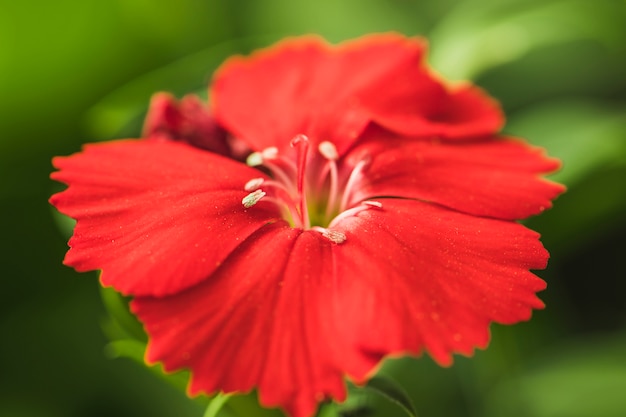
[430,0,626,79]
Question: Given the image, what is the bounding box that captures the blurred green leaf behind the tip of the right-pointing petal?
[506,100,626,253]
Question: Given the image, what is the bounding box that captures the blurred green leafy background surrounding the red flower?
[0,0,626,417]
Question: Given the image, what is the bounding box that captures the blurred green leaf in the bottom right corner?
[485,335,626,417]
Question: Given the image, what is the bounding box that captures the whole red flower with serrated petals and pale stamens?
[51,34,563,417]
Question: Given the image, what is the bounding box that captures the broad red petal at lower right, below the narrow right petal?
[333,199,548,364]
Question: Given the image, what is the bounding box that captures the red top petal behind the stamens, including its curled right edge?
[211,34,504,153]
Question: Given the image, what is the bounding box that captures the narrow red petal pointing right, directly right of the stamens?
[354,131,564,220]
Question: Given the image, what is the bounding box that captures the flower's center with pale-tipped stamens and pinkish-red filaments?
[241,135,382,243]
